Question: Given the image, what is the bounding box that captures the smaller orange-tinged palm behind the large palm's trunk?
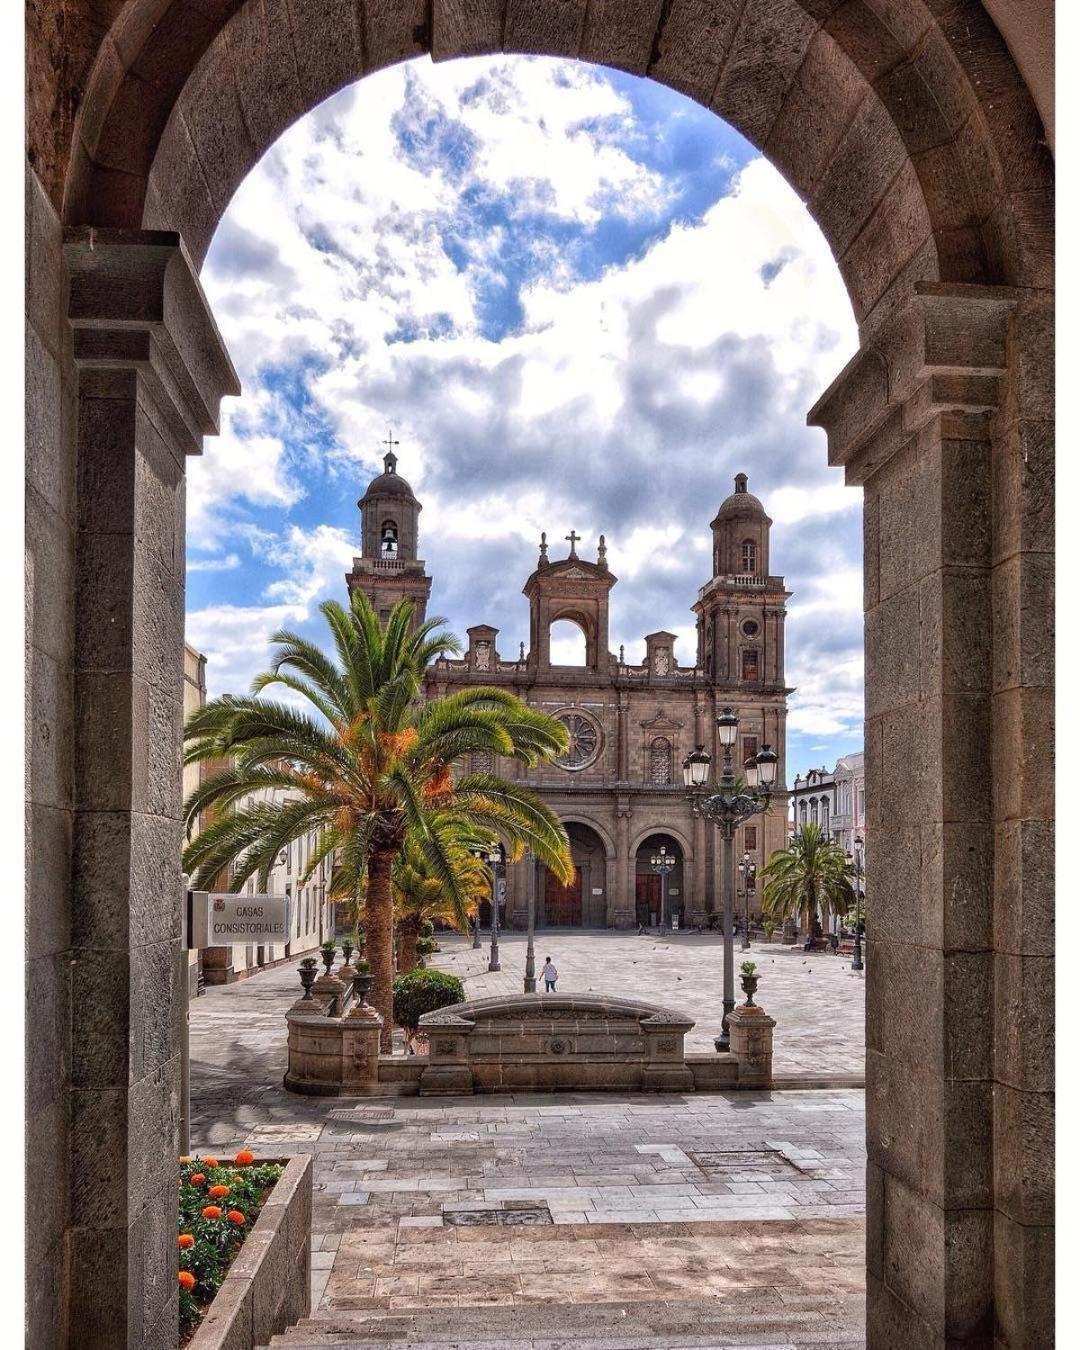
[392,815,490,973]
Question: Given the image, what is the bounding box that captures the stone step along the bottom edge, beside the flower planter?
[261,1289,864,1350]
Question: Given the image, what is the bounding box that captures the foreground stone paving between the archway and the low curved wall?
[190,936,865,1350]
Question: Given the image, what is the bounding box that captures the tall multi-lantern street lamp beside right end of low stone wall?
[683,707,778,1052]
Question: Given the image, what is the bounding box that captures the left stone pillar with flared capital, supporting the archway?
[63,230,239,1350]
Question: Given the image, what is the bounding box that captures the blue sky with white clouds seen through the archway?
[188,57,863,774]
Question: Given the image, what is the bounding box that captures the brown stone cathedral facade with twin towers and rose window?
[347,452,792,927]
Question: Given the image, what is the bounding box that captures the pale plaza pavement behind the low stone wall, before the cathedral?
[429,929,864,1079]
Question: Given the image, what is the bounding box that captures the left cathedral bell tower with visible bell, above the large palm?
[346,435,431,624]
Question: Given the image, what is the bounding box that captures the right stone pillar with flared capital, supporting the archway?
[810,284,1031,1347]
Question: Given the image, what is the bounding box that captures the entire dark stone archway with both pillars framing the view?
[27,0,1053,1346]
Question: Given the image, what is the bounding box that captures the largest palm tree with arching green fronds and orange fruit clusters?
[184,591,572,1050]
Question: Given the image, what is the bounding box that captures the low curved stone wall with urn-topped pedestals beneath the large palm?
[278,981,775,1096]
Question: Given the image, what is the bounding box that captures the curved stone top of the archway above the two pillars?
[54,0,1052,337]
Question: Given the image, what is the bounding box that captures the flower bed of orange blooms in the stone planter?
[177,1152,285,1345]
